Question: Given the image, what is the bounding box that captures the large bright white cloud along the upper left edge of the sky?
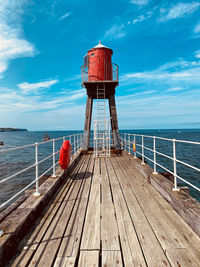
[0,0,35,78]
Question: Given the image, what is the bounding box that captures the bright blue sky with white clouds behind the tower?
[0,0,200,130]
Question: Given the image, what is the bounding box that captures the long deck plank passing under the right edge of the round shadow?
[57,158,94,257]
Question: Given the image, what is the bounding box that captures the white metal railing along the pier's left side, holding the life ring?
[0,133,83,209]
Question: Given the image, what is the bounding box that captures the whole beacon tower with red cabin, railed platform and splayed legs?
[81,42,121,150]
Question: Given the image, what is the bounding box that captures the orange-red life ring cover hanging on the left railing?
[59,140,72,170]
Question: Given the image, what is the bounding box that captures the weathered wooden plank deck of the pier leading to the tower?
[9,155,200,267]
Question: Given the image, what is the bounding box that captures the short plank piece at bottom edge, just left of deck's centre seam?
[78,250,99,267]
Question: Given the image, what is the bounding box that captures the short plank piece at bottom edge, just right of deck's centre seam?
[102,251,123,267]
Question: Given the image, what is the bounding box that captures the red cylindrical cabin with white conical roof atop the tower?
[88,43,113,81]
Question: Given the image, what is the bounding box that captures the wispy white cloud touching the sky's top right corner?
[160,2,200,22]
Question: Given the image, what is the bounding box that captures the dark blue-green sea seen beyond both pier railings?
[0,129,200,209]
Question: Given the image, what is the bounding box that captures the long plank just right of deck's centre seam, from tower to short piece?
[101,158,120,250]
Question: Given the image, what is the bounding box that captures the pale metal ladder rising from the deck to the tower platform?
[94,84,110,157]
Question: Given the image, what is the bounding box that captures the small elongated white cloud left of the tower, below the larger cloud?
[17,79,58,94]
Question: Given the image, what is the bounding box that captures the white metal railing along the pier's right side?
[121,133,200,195]
